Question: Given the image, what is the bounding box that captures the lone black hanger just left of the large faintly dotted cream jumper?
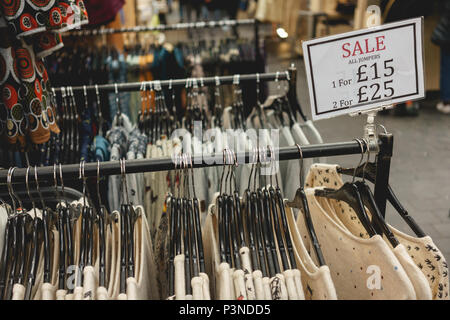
[286,144,326,266]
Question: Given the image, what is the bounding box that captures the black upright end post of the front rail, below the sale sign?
[375,133,394,217]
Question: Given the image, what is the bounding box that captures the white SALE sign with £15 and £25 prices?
[303,18,425,120]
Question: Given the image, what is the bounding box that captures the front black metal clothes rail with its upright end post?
[0,133,393,216]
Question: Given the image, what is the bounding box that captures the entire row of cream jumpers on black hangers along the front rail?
[0,133,449,300]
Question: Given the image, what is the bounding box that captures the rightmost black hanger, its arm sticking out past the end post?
[337,162,426,238]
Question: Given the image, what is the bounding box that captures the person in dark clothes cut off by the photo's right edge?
[431,0,450,114]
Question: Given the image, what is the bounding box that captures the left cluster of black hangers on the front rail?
[0,156,142,300]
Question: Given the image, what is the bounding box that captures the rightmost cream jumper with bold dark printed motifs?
[307,164,449,300]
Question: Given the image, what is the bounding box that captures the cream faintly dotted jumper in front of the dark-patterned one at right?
[297,188,416,300]
